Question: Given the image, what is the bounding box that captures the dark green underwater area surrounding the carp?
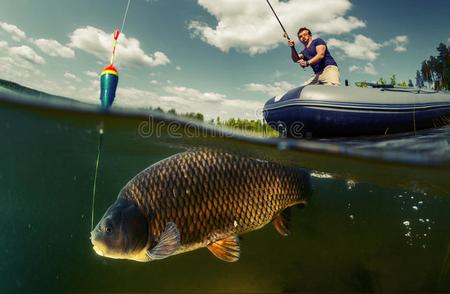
[0,92,450,293]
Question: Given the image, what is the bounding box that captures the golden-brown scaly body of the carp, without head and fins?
[119,150,309,253]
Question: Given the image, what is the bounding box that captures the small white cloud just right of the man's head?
[328,35,383,61]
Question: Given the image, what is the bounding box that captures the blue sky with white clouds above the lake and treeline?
[0,0,450,118]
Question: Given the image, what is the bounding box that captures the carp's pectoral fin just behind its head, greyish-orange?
[147,222,180,260]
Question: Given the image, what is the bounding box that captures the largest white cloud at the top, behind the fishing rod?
[188,0,365,55]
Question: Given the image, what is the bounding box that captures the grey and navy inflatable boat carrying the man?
[263,85,450,138]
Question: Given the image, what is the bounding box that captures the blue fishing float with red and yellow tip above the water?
[100,30,120,108]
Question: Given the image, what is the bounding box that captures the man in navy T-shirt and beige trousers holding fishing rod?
[288,27,341,86]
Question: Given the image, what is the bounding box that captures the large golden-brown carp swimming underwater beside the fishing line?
[91,150,310,262]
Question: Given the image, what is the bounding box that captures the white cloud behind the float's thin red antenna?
[69,26,170,66]
